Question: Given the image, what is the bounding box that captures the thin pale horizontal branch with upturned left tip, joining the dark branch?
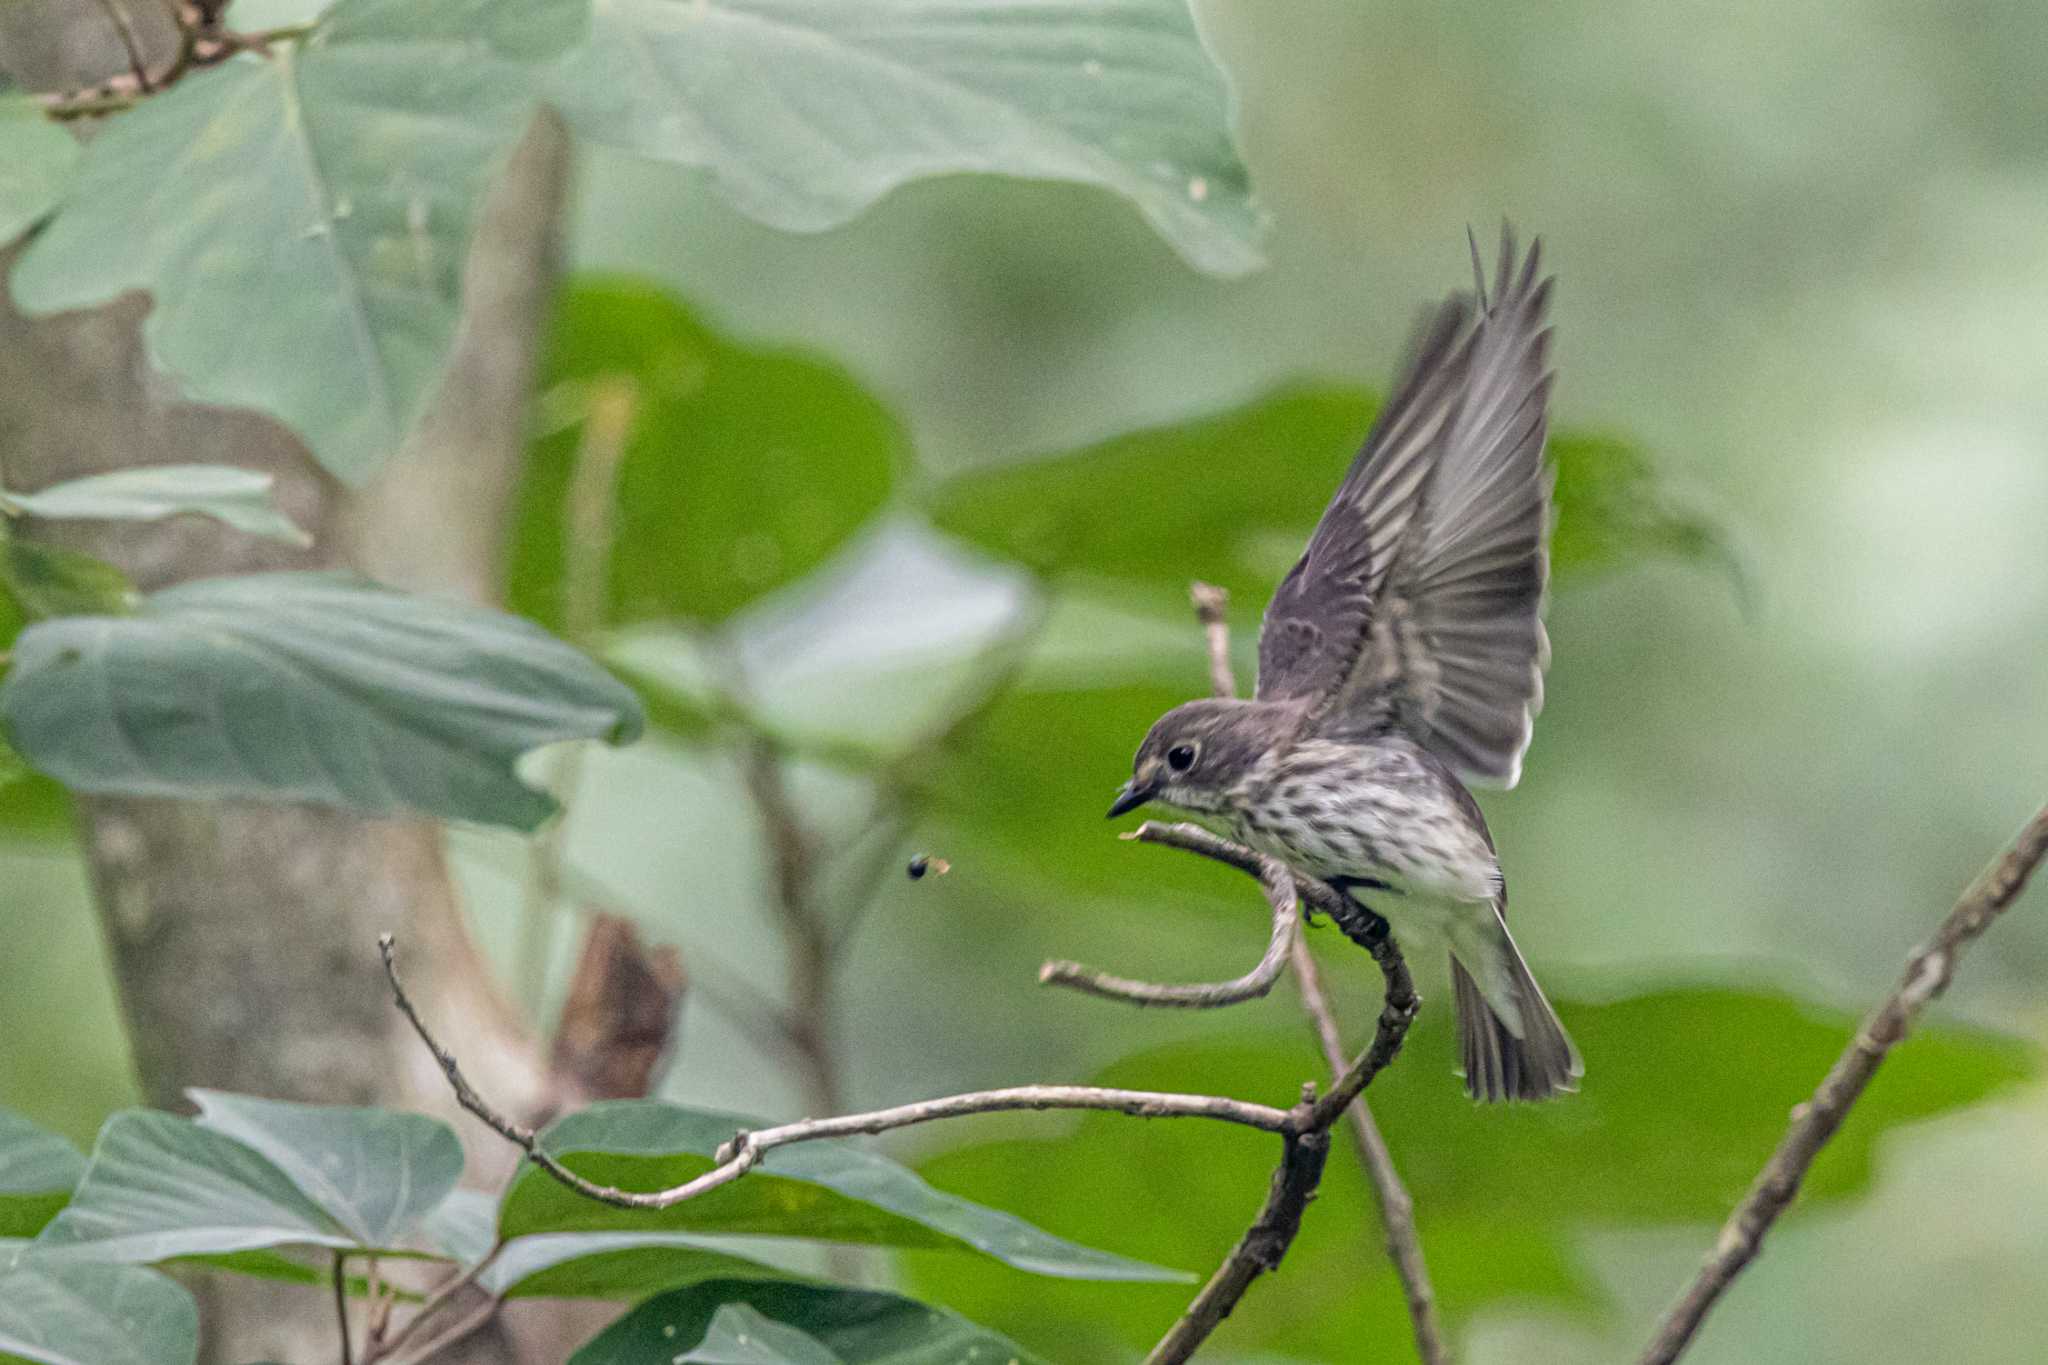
[377,933,1298,1209]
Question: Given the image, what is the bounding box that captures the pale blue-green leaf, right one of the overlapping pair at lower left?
[190,1091,463,1246]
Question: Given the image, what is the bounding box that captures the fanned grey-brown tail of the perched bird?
[1450,913,1585,1101]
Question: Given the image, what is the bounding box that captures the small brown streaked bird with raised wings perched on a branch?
[1110,227,1585,1101]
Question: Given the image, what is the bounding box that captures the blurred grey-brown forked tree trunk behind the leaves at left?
[0,15,594,1365]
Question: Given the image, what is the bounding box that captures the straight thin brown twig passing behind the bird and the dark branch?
[1179,583,1450,1365]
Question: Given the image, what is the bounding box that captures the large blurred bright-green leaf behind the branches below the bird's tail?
[911,986,2038,1365]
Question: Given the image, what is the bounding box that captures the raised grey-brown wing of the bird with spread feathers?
[1257,233,1550,786]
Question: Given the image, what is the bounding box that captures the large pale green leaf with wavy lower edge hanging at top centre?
[553,0,1264,276]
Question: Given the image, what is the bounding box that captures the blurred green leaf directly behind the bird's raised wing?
[926,385,1729,605]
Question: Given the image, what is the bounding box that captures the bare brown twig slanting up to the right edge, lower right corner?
[1640,808,2048,1365]
